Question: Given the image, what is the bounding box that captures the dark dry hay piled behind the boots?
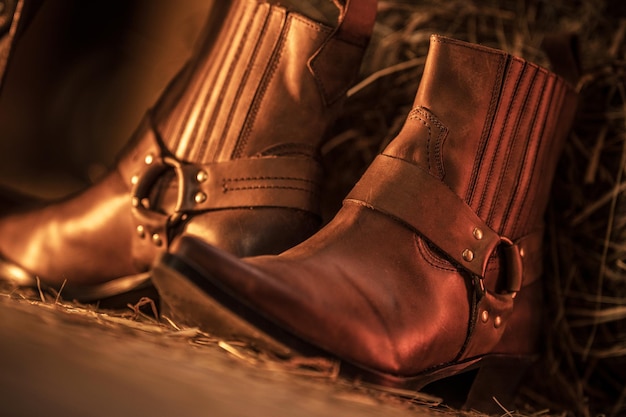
[323,0,626,416]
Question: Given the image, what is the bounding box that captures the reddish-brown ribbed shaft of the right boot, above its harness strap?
[385,36,576,239]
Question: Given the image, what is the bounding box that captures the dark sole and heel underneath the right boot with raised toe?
[152,253,534,414]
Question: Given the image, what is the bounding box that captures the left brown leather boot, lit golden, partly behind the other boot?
[0,0,376,301]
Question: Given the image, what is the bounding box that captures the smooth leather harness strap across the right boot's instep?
[344,154,542,293]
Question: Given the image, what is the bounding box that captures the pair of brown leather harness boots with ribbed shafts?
[0,0,576,412]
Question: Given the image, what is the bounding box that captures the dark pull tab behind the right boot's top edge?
[541,32,581,87]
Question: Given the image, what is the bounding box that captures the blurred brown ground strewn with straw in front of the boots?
[0,292,466,417]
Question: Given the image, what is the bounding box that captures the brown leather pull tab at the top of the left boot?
[308,0,378,105]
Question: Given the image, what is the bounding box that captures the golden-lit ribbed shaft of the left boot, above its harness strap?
[157,0,376,163]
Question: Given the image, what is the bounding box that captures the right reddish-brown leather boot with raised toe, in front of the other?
[153,36,576,412]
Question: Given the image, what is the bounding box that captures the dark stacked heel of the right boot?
[463,356,533,414]
